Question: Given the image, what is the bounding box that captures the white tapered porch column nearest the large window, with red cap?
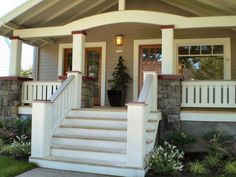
[161,25,176,74]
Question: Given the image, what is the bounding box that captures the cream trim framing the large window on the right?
[174,38,231,80]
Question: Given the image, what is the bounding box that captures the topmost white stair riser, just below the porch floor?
[67,110,127,119]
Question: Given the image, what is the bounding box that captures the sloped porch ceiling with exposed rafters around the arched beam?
[0,0,236,46]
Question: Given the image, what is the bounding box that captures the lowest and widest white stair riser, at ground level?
[30,158,145,177]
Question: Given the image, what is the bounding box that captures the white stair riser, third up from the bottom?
[51,138,126,150]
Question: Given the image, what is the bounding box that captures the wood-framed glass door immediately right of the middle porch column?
[85,47,102,106]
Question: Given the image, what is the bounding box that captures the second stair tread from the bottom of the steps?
[51,144,126,154]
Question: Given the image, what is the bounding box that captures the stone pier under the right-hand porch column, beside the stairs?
[158,75,183,137]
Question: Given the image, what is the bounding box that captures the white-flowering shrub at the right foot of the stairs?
[145,142,184,174]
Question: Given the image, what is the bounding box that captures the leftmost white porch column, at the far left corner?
[9,36,22,76]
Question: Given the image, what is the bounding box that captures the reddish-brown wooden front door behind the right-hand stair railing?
[139,44,162,92]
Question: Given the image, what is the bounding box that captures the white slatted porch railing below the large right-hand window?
[181,81,236,108]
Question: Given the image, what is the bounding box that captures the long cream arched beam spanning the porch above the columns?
[13,10,236,38]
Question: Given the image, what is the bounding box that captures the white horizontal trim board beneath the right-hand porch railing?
[180,111,236,122]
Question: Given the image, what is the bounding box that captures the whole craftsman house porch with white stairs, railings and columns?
[0,0,236,176]
